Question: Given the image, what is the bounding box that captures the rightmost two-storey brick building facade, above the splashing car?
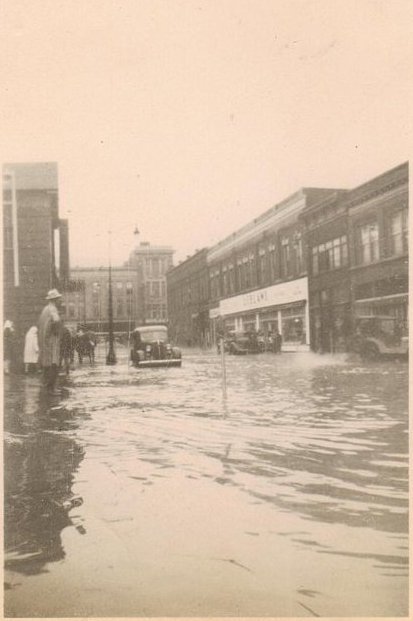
[347,162,409,333]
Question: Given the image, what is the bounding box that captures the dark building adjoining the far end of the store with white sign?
[166,248,211,347]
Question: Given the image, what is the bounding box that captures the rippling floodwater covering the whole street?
[4,350,408,617]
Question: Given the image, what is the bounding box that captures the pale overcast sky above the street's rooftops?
[0,0,413,266]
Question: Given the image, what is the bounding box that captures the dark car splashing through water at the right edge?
[350,315,409,359]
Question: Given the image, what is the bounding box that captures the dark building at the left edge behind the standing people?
[3,162,70,365]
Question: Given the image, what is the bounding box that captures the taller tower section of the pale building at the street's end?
[126,242,174,324]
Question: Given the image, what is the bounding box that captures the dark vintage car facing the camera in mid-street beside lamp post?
[131,325,182,367]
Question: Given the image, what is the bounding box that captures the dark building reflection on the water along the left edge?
[4,387,83,574]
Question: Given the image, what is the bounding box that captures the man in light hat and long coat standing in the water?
[39,289,62,395]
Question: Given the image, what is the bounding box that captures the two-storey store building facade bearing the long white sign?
[207,188,338,351]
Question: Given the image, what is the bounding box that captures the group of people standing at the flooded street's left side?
[3,289,96,394]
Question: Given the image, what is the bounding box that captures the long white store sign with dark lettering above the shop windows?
[219,277,308,317]
